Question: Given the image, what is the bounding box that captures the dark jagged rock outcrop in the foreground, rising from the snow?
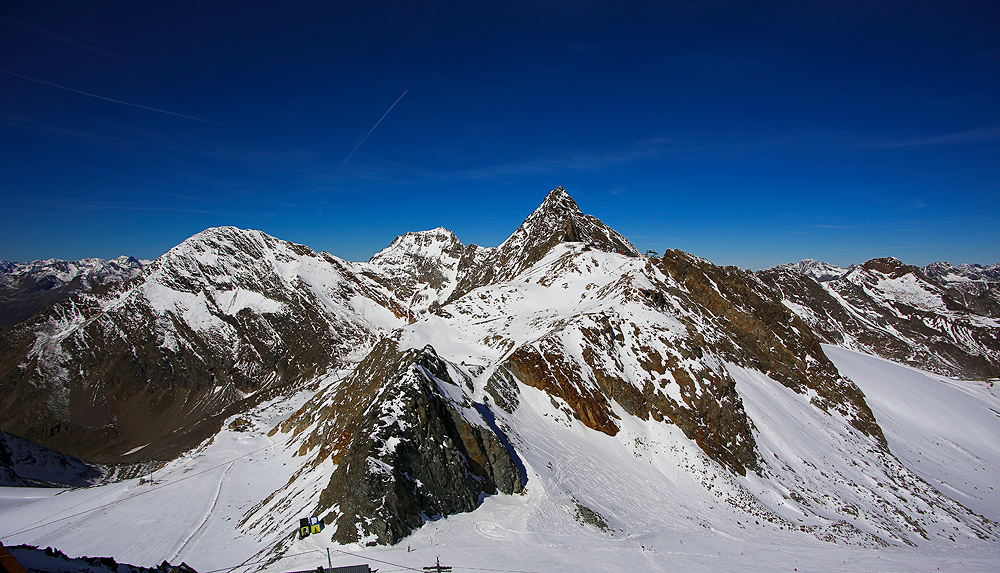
[282,340,523,544]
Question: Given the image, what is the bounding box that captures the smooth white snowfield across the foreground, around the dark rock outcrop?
[0,344,1000,573]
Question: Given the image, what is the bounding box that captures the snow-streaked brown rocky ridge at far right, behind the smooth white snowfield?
[757,258,1000,378]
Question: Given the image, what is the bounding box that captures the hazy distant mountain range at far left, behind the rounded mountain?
[0,257,143,330]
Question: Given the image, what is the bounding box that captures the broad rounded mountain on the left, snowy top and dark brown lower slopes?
[0,228,406,463]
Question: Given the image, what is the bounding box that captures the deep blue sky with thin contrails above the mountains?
[0,0,1000,269]
